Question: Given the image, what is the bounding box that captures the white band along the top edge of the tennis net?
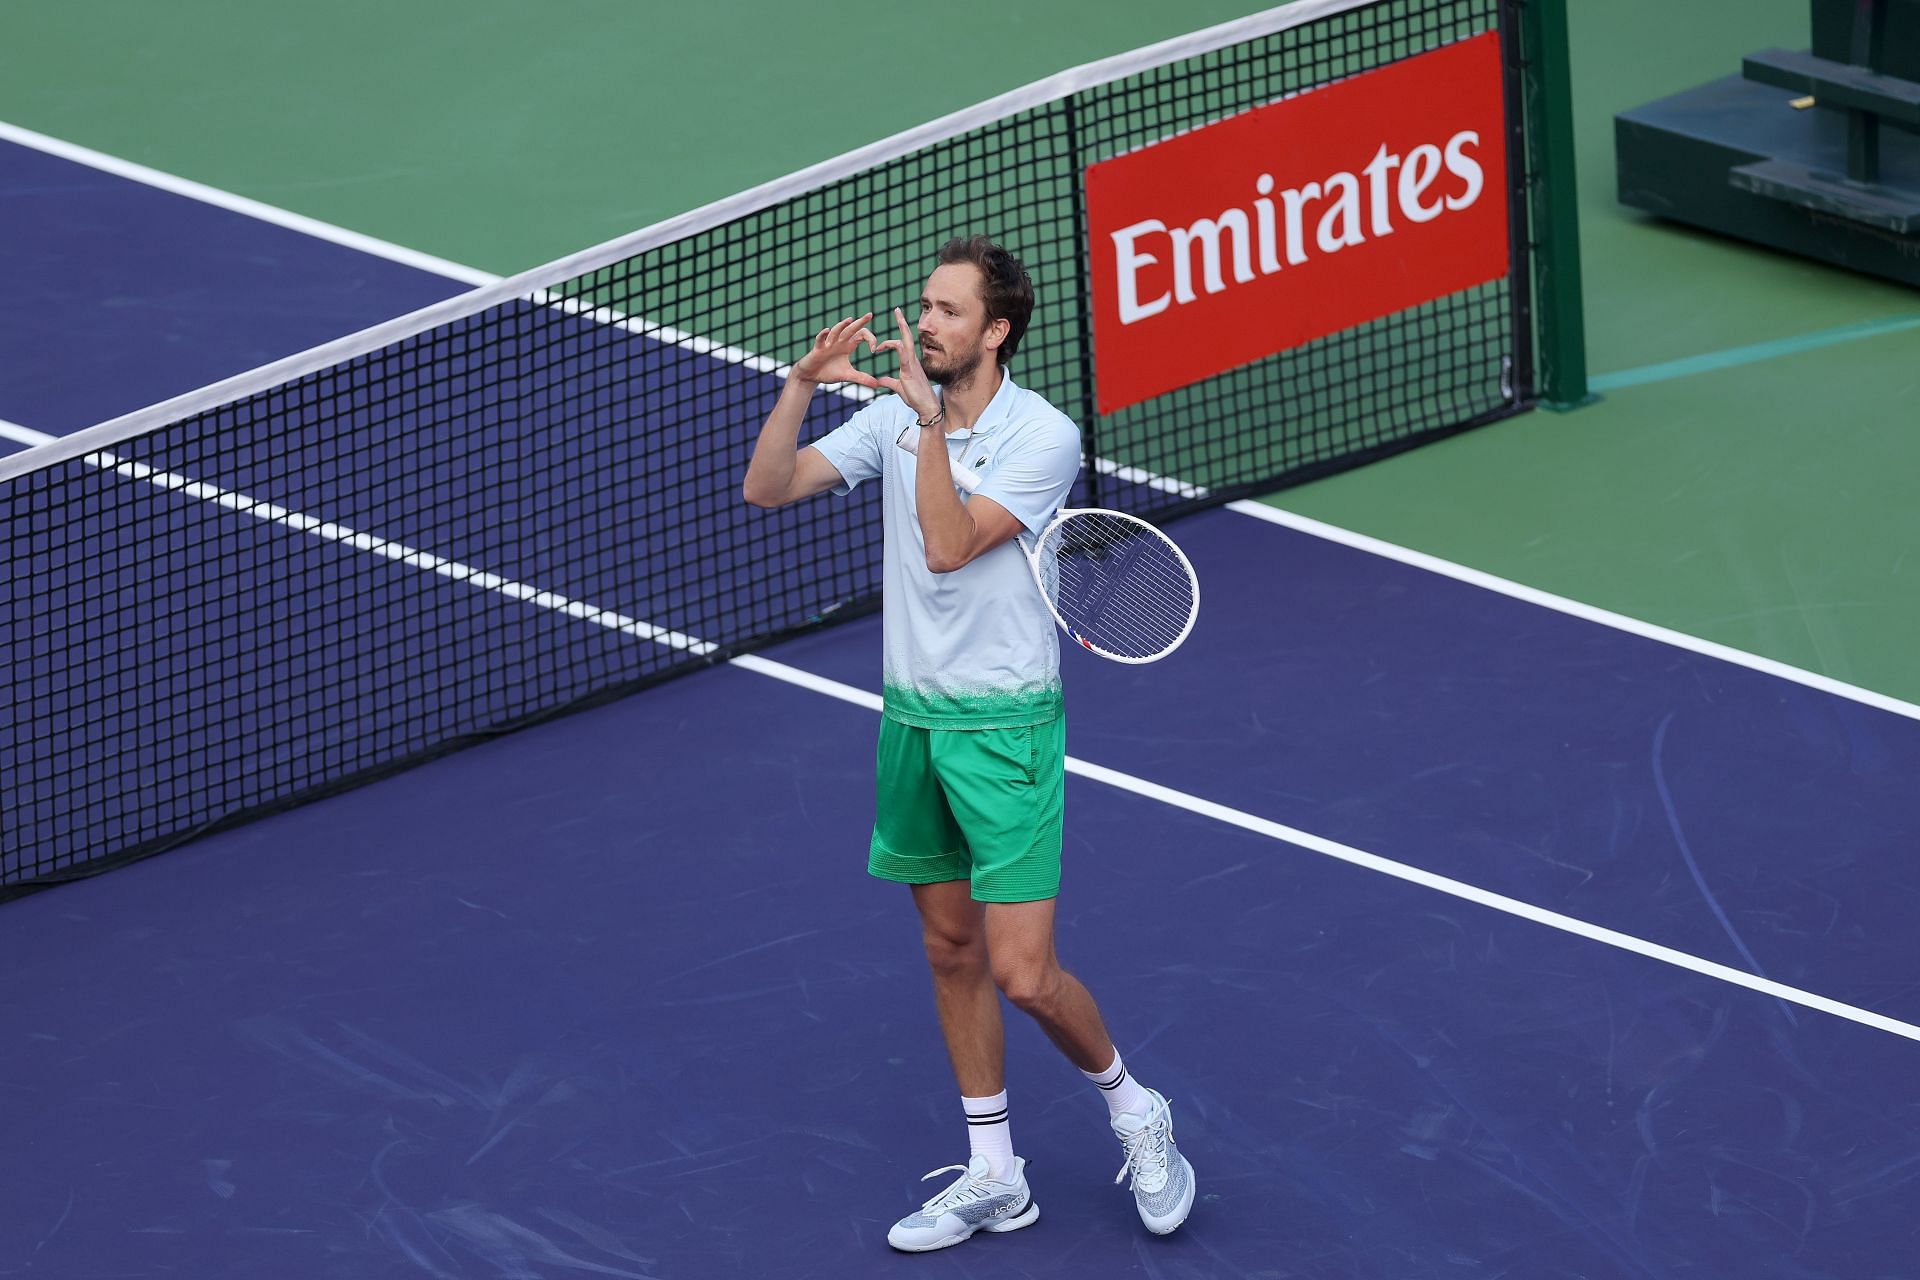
[0,0,1384,484]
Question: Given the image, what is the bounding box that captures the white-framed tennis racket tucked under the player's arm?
[897,426,1200,662]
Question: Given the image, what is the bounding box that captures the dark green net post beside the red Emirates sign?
[1519,0,1599,411]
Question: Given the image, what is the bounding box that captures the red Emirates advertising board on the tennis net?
[1087,33,1509,413]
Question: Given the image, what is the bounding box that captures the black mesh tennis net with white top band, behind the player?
[0,0,1532,894]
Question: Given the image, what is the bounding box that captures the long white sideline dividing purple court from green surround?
[0,121,1920,720]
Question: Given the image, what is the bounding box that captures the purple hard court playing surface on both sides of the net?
[0,45,1920,1280]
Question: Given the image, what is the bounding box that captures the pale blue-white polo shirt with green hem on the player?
[814,370,1081,729]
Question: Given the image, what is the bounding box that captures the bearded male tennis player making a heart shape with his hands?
[743,236,1194,1251]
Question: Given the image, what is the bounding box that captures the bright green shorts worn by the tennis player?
[866,716,1068,902]
